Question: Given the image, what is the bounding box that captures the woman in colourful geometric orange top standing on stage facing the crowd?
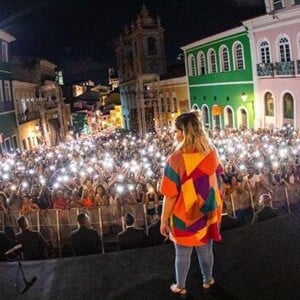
[160,112,223,296]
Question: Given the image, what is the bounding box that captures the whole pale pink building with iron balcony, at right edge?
[243,0,300,129]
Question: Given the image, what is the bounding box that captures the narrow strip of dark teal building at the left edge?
[0,30,18,152]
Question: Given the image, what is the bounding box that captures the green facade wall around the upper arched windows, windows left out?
[182,27,255,128]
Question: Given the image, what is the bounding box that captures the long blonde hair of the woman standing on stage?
[175,112,212,152]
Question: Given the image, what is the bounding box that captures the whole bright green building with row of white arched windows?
[181,26,255,128]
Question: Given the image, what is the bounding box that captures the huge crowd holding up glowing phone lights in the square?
[0,122,300,260]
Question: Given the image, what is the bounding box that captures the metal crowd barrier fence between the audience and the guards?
[0,185,300,257]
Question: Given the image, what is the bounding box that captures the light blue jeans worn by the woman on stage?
[175,240,214,288]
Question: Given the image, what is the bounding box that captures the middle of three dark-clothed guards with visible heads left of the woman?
[71,213,101,256]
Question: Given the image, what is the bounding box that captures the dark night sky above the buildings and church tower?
[0,0,265,84]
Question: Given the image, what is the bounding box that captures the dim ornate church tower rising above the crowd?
[115,7,166,133]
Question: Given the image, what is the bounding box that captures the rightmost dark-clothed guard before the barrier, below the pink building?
[251,194,279,224]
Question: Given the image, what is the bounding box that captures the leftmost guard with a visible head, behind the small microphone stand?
[16,216,49,260]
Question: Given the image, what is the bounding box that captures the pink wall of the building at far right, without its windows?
[244,0,300,128]
